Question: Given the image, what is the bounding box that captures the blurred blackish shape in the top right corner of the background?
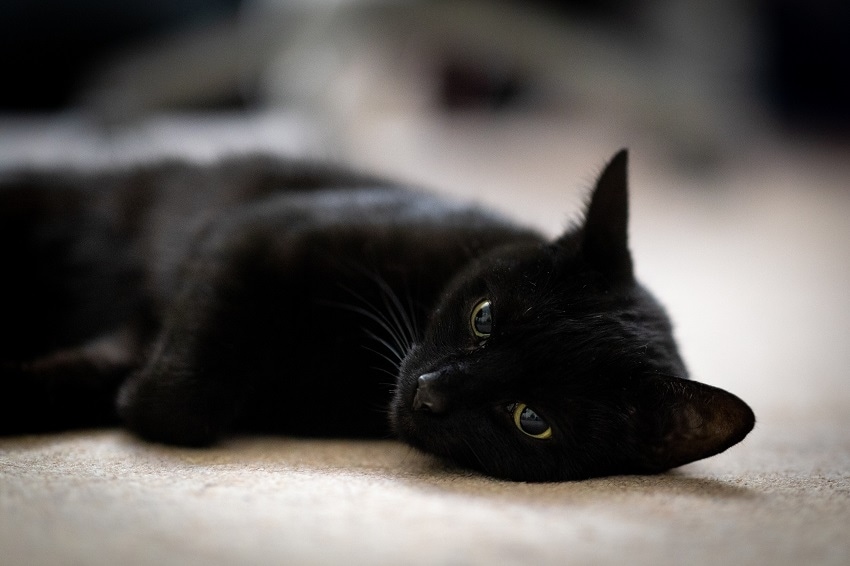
[760,0,850,135]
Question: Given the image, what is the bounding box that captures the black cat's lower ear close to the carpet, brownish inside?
[633,376,755,471]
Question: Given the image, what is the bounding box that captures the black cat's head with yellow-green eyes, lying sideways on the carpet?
[391,151,755,481]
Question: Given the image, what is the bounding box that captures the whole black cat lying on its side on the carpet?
[0,151,754,481]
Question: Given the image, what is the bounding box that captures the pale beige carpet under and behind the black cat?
[0,113,850,565]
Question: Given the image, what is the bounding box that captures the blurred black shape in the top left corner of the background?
[0,0,241,112]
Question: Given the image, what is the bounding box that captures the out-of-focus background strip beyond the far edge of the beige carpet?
[0,0,850,158]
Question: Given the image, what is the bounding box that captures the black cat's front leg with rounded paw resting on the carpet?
[118,215,292,446]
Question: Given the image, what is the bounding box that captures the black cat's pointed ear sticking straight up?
[568,149,632,280]
